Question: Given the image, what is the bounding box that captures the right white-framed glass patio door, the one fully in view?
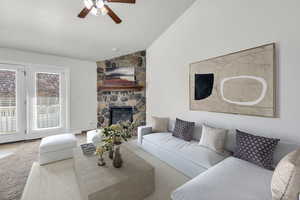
[27,67,67,138]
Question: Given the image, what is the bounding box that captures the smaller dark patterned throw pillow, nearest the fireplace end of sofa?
[172,118,195,141]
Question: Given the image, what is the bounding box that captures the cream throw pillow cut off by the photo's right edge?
[271,149,300,200]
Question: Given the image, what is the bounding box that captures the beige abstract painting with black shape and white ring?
[190,43,276,117]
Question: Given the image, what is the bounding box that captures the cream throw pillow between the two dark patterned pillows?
[199,125,227,153]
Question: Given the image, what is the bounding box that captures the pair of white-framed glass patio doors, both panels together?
[0,64,68,143]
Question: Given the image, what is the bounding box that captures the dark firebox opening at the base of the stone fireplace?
[109,106,133,125]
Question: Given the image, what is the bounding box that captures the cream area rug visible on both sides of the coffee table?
[22,140,189,200]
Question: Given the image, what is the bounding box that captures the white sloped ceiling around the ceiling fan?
[0,0,195,61]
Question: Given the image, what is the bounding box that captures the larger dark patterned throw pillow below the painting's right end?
[233,130,280,170]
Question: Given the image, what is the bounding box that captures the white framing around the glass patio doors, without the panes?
[0,60,70,144]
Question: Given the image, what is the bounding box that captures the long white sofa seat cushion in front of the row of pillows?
[143,133,226,169]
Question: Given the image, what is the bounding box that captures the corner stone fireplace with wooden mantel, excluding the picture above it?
[97,51,146,127]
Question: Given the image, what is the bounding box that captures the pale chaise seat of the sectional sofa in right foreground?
[171,157,272,200]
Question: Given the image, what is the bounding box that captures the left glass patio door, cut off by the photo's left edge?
[0,64,26,142]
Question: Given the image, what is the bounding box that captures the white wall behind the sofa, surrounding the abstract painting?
[147,0,300,143]
